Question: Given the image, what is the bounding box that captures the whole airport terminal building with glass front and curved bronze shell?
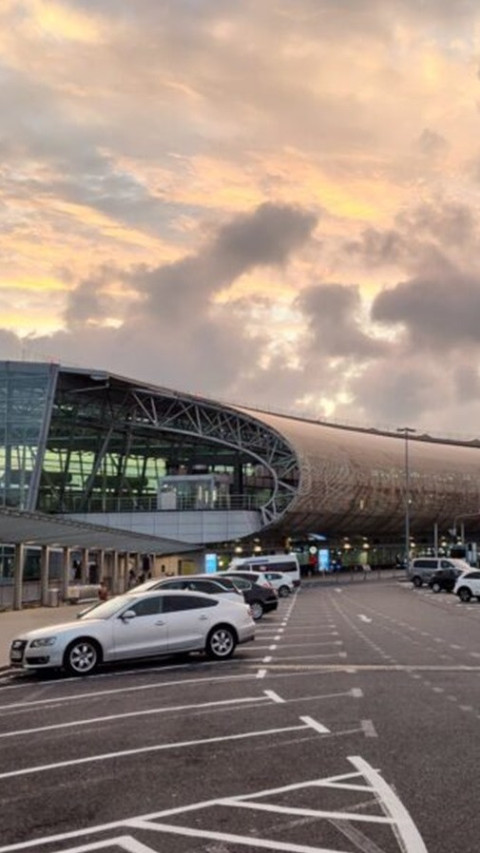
[0,361,480,604]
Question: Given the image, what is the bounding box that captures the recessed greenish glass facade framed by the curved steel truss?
[36,369,284,513]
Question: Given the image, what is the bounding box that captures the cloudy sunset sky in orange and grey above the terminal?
[0,0,480,437]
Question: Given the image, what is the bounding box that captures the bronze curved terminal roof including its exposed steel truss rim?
[63,364,480,539]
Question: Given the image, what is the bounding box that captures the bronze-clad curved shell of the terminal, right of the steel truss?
[238,402,480,537]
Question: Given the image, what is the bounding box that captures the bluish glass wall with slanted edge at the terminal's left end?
[0,362,57,510]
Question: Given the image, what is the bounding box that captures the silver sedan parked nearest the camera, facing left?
[10,591,255,675]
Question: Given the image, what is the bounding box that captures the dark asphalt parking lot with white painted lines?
[0,579,480,853]
